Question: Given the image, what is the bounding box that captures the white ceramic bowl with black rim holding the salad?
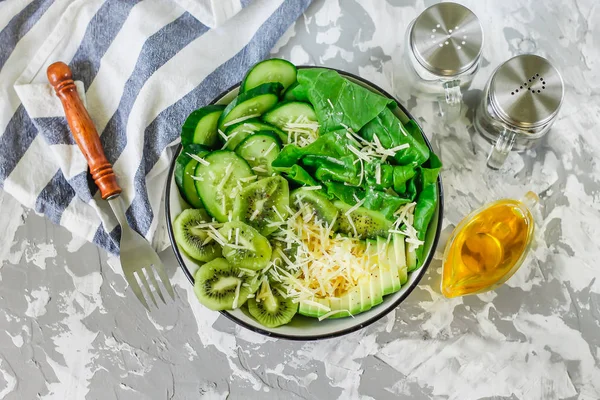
[165,67,444,340]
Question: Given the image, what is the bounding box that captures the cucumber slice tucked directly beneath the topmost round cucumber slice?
[218,83,283,131]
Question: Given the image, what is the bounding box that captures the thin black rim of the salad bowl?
[165,66,444,341]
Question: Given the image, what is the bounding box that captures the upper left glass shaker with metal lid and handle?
[405,3,483,120]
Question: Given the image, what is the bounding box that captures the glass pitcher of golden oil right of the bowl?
[441,192,539,297]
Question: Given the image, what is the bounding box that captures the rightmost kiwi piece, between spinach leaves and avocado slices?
[333,200,392,239]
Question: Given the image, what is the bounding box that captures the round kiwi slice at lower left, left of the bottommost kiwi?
[194,258,259,311]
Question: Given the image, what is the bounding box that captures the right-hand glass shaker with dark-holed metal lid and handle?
[475,54,564,169]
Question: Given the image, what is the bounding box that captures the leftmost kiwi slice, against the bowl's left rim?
[173,209,221,262]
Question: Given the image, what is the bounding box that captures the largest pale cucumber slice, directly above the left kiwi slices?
[194,150,254,222]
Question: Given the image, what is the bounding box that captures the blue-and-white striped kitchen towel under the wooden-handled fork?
[0,0,310,253]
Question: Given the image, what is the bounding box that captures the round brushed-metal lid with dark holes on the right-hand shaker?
[490,54,564,129]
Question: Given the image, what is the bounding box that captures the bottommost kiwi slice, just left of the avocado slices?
[248,280,298,328]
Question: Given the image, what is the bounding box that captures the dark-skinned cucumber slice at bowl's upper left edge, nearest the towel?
[181,105,225,148]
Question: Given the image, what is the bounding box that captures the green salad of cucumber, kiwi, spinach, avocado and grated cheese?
[173,59,441,328]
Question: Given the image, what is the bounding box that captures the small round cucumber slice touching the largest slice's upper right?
[235,131,281,176]
